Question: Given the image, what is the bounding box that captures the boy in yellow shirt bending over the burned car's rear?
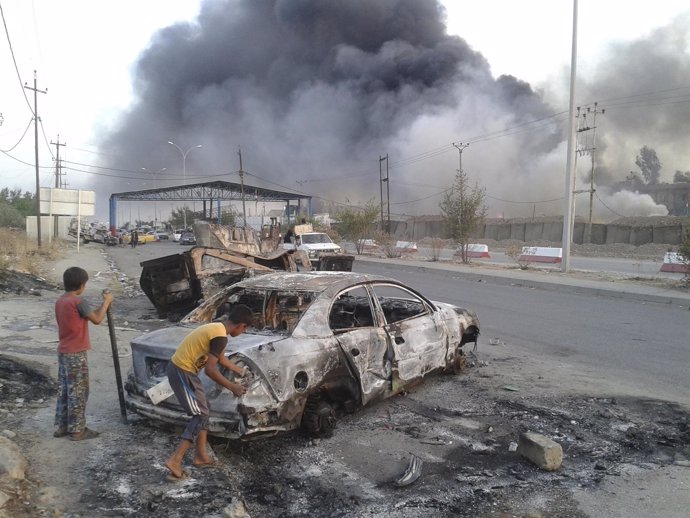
[165,304,252,481]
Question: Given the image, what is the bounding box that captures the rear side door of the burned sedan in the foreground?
[328,286,392,405]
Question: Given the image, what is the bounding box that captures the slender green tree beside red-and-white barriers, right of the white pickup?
[440,171,487,263]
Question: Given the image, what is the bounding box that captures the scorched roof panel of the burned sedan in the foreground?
[235,272,388,292]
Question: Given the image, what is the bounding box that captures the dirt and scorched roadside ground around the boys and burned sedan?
[0,245,690,518]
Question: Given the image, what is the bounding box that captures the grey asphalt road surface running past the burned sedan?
[109,242,690,402]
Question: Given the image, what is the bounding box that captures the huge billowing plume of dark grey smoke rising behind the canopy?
[103,0,690,219]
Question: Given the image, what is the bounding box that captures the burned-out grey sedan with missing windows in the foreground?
[125,272,479,438]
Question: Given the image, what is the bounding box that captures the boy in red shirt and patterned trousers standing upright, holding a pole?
[53,266,113,441]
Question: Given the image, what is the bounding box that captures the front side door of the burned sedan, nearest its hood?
[371,282,447,391]
